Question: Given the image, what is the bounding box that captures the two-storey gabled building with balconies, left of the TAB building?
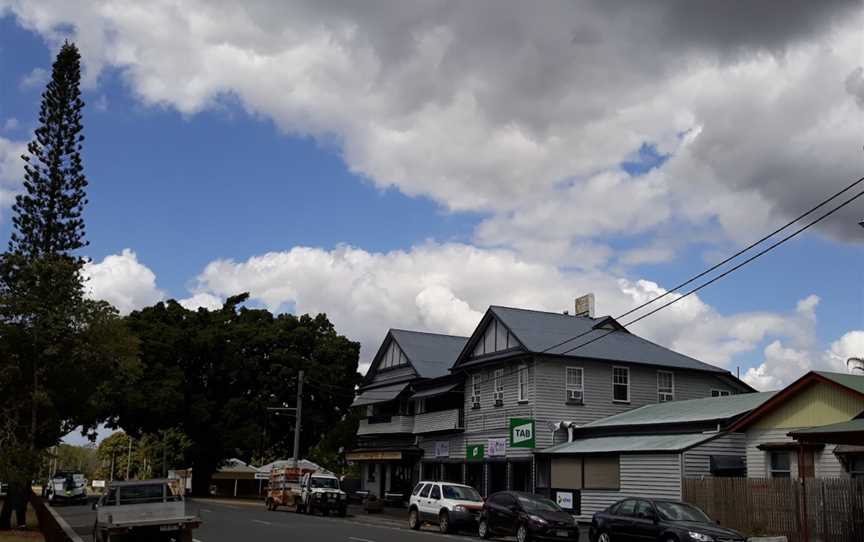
[345,329,467,500]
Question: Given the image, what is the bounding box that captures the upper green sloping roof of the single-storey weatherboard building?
[582,391,777,428]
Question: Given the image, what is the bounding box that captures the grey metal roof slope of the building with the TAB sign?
[489,305,729,374]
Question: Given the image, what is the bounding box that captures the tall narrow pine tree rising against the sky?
[9,42,87,258]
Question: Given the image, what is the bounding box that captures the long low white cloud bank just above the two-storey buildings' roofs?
[196,243,832,369]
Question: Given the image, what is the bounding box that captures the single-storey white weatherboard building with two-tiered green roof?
[536,392,774,521]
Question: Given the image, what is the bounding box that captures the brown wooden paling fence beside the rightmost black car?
[682,478,864,542]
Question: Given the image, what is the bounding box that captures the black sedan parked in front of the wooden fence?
[588,499,746,542]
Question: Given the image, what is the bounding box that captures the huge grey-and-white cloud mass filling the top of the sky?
[0,0,864,262]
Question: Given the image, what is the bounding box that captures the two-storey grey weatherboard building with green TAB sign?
[449,306,754,495]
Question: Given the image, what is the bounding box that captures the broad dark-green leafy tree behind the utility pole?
[118,294,359,495]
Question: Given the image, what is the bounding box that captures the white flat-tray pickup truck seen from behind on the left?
[93,480,201,542]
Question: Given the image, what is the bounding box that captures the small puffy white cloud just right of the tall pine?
[82,248,165,314]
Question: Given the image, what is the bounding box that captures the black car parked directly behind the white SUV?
[477,491,579,542]
